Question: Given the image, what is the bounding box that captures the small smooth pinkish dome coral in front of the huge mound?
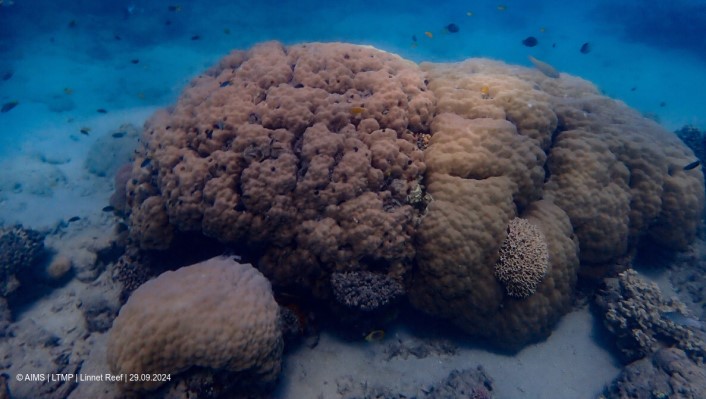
[107,257,282,391]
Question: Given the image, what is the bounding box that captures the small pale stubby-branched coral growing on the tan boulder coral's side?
[495,218,549,298]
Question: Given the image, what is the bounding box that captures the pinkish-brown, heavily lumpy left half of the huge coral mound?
[128,43,433,296]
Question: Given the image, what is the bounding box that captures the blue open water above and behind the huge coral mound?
[0,0,706,156]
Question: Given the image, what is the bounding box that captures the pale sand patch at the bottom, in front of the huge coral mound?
[275,308,620,399]
